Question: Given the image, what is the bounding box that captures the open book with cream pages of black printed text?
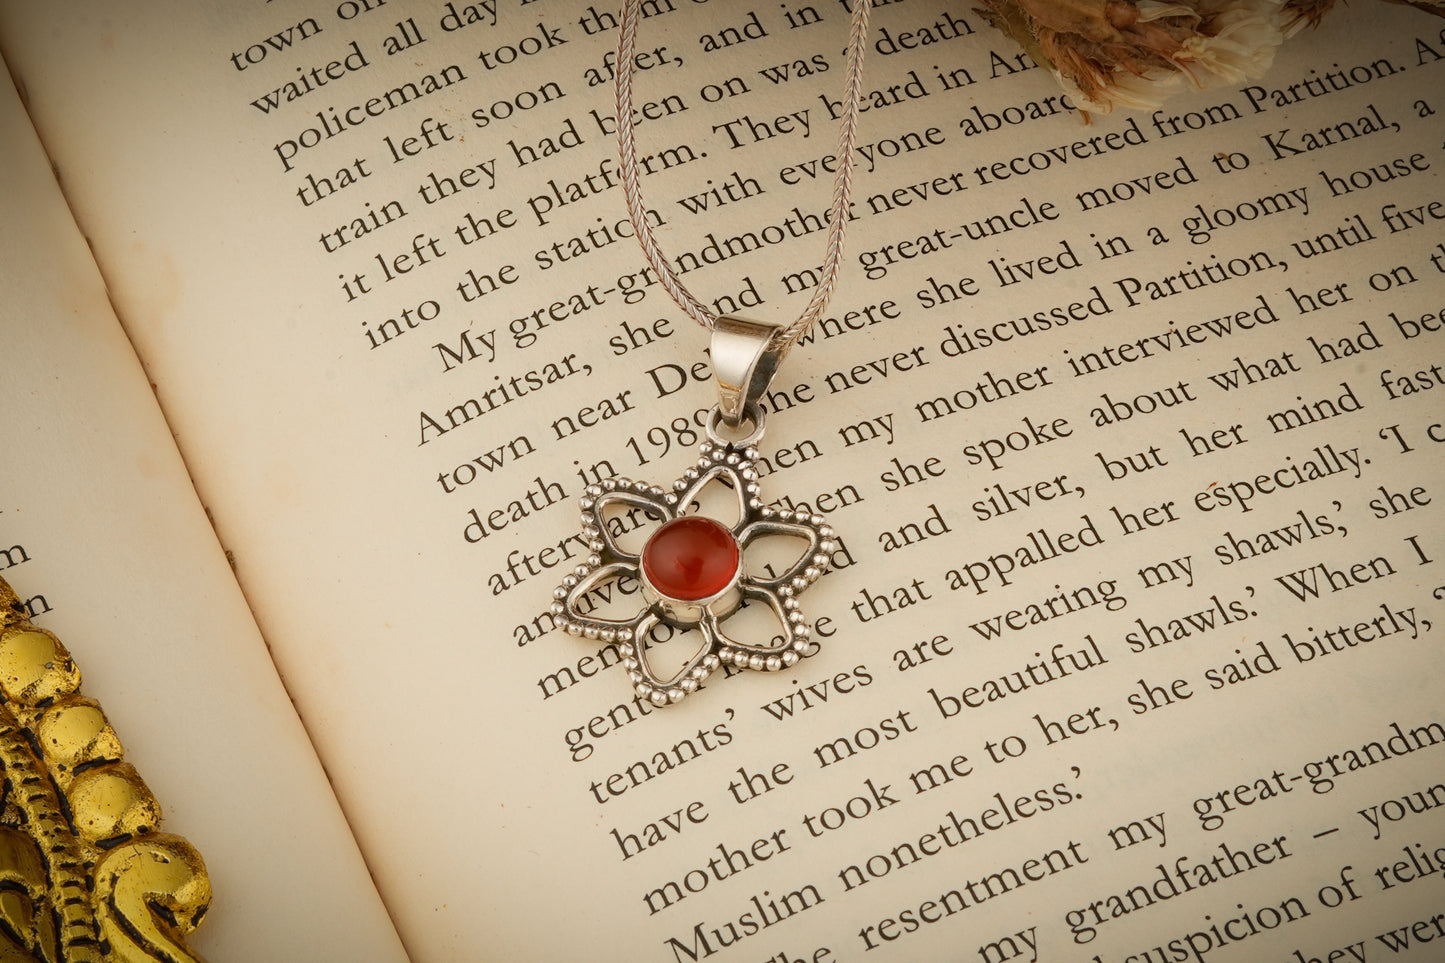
[0,0,1445,963]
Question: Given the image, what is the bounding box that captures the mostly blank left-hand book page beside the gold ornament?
[0,60,406,963]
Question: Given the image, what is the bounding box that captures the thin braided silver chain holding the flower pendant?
[617,0,871,357]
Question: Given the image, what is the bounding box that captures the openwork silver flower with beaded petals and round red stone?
[552,435,837,706]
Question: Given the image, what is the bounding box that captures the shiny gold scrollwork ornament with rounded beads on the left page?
[0,578,211,963]
